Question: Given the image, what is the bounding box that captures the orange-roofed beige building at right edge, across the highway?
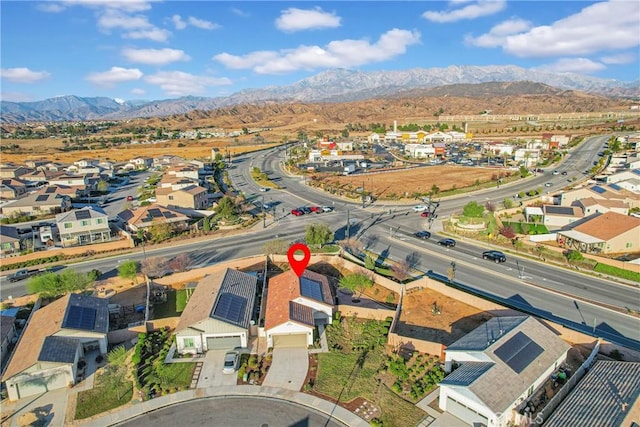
[556,211,640,254]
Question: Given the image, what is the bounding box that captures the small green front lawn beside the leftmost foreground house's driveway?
[75,374,133,420]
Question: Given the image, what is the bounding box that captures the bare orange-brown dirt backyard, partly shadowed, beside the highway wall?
[395,289,493,345]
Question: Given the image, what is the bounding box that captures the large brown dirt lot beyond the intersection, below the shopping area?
[317,165,512,198]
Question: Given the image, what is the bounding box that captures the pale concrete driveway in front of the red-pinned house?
[262,348,309,391]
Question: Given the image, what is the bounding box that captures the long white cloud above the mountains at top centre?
[212,29,420,74]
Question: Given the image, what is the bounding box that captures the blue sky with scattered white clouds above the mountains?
[0,0,640,102]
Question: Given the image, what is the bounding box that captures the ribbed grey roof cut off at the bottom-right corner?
[544,360,640,427]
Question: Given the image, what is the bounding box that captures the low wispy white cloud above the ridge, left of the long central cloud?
[144,71,232,96]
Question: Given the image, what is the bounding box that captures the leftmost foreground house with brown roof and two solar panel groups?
[2,294,109,400]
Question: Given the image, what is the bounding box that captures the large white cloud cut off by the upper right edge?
[467,1,640,58]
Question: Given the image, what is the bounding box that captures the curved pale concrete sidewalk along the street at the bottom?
[70,385,369,427]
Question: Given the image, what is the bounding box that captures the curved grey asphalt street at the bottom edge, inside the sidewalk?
[118,397,345,427]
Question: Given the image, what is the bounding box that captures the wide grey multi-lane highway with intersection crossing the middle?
[2,136,640,350]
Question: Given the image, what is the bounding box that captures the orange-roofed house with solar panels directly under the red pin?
[264,270,334,348]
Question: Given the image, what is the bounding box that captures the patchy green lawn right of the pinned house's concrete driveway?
[314,349,425,427]
